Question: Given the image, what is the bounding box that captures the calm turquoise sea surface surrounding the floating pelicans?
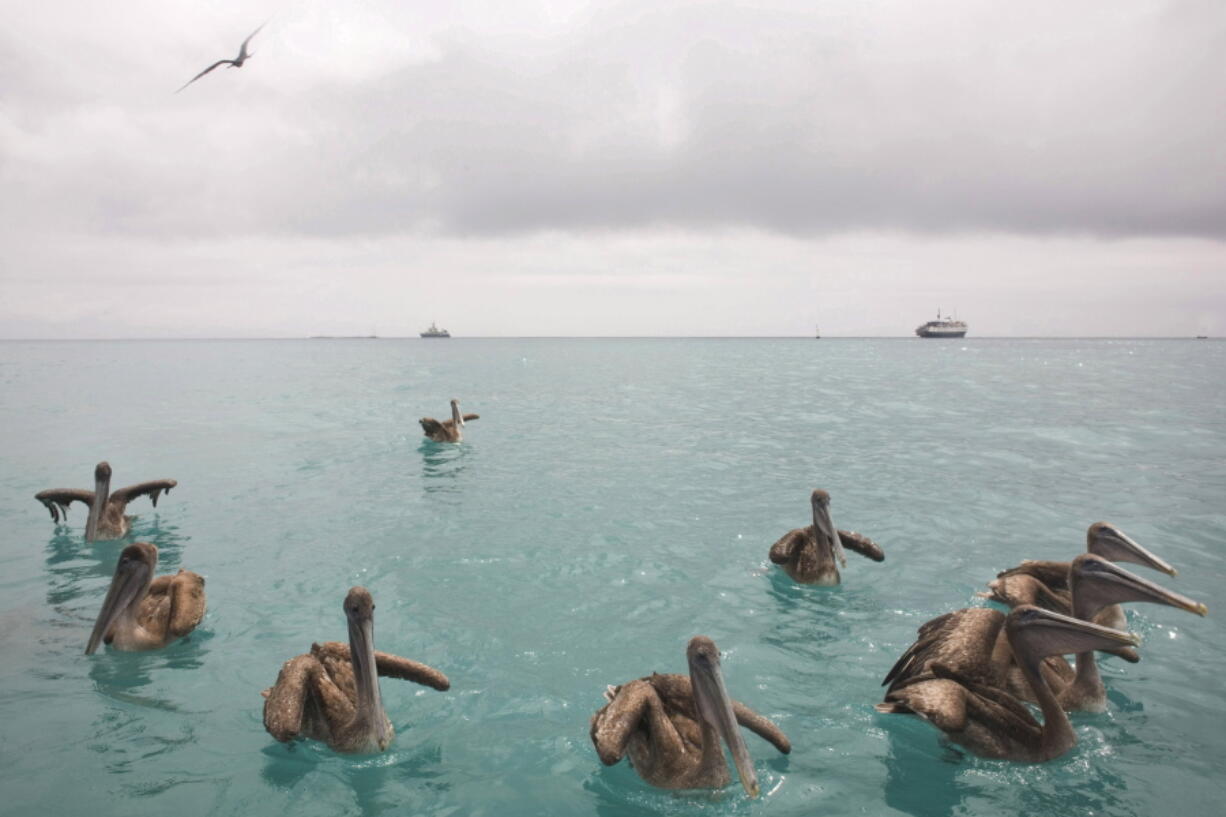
[0,339,1226,817]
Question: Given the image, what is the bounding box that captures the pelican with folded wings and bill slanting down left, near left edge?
[85,542,205,655]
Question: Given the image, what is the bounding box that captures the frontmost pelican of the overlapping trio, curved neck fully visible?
[877,605,1140,763]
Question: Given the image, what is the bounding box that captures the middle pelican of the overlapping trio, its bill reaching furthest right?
[883,553,1209,712]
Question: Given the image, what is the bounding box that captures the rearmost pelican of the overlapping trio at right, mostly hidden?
[981,521,1178,629]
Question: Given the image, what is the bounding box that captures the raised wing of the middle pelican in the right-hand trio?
[881,607,1004,697]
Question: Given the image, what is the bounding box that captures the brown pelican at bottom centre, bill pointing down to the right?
[591,635,792,797]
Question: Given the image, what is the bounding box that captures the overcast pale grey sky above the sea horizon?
[0,0,1226,337]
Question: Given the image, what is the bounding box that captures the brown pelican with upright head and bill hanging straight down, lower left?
[261,588,451,753]
